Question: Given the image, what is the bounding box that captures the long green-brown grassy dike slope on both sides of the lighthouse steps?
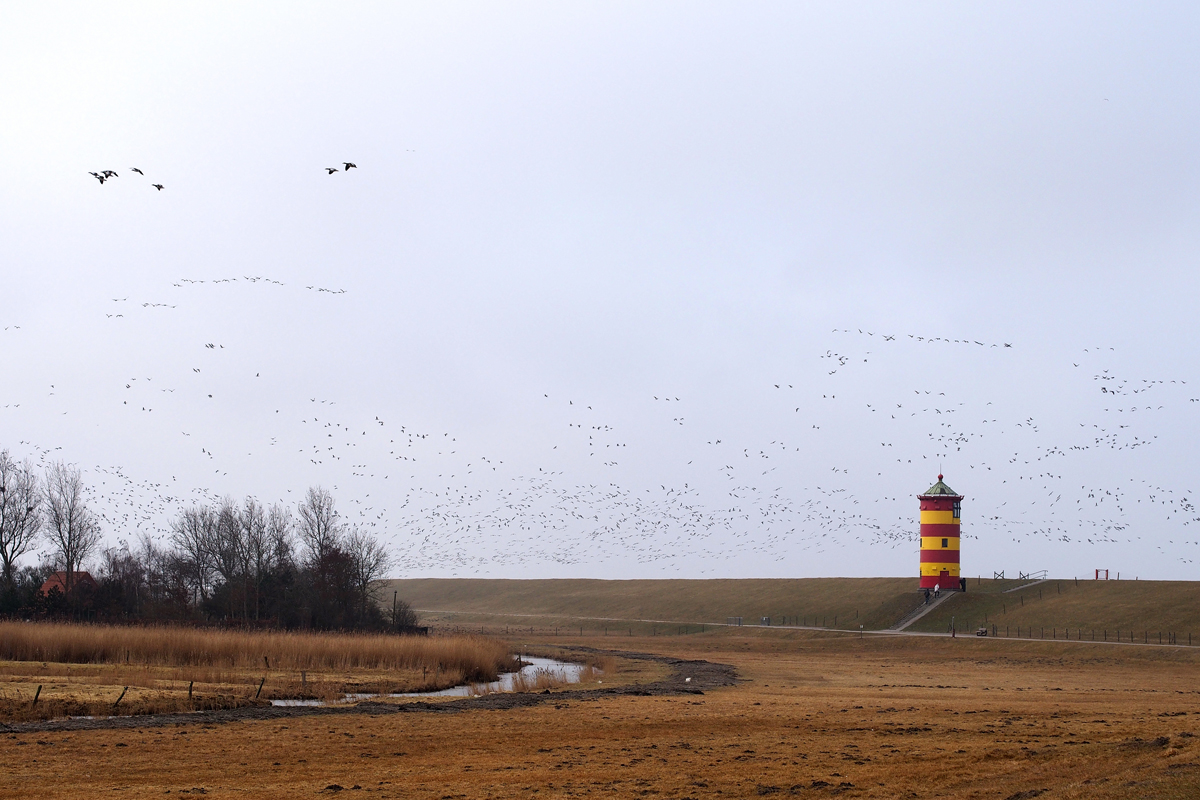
[380,578,1200,645]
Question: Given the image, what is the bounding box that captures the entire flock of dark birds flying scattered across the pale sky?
[0,162,1200,575]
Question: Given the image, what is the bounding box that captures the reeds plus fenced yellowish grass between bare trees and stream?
[0,622,516,722]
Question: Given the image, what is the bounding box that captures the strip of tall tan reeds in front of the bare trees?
[0,622,514,681]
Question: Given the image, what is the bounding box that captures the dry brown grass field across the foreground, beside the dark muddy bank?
[0,628,1200,800]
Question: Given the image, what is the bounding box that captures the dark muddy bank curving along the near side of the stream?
[0,648,739,734]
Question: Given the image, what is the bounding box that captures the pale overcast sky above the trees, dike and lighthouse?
[0,2,1200,578]
